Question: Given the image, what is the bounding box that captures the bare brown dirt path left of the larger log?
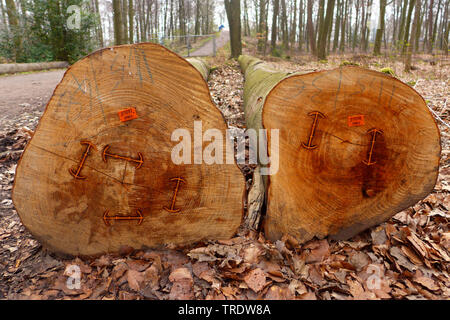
[0,69,65,122]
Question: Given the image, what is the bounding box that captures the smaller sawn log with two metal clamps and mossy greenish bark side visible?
[239,57,441,242]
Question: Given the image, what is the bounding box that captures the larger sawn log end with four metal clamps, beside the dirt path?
[13,43,245,256]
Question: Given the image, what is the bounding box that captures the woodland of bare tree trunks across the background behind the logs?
[0,0,450,63]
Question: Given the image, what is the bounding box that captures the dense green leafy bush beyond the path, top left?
[0,0,95,63]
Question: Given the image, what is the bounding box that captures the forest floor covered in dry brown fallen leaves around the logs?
[0,45,450,300]
